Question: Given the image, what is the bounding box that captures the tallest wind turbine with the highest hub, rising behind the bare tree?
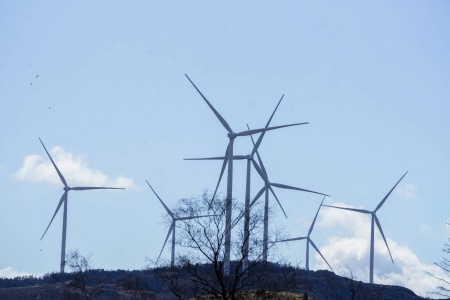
[186,75,306,276]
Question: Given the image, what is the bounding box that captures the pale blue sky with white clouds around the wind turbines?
[0,1,450,294]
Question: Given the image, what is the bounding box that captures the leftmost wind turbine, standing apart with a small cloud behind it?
[39,138,124,273]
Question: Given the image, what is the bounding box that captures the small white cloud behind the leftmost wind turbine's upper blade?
[14,147,135,188]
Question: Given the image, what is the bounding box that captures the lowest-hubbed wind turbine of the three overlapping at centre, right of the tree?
[250,136,329,261]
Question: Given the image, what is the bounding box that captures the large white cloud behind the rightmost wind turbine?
[315,203,450,296]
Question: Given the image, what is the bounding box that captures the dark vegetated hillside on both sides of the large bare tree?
[0,264,423,300]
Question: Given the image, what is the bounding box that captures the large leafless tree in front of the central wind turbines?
[156,193,296,299]
